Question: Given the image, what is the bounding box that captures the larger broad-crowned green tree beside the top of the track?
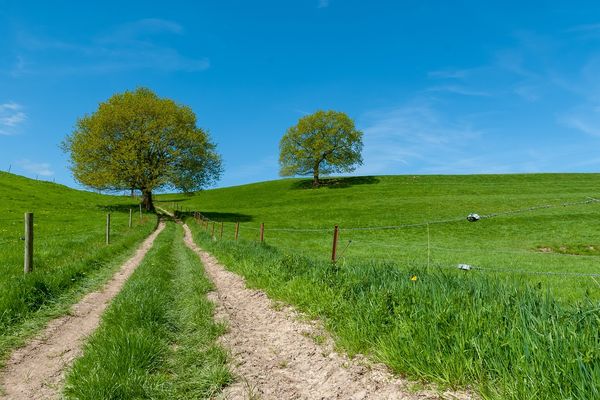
[63,88,222,211]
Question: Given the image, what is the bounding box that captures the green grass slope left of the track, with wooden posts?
[0,172,156,358]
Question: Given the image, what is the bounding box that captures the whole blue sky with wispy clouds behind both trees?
[0,0,600,186]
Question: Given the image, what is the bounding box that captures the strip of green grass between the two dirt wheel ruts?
[65,222,232,399]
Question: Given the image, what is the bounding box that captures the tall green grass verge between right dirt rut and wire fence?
[188,218,600,400]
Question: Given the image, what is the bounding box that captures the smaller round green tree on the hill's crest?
[279,111,362,187]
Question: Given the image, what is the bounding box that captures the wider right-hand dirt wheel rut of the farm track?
[184,225,471,400]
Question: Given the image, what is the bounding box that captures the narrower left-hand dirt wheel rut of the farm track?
[0,222,165,400]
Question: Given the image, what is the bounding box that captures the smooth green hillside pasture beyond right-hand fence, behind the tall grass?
[159,174,600,301]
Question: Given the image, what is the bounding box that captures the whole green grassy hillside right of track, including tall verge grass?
[160,174,600,400]
